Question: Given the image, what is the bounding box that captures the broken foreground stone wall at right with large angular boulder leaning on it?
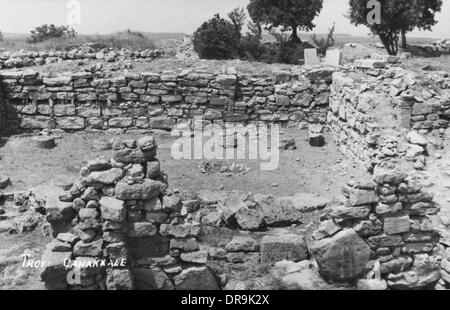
[311,169,443,289]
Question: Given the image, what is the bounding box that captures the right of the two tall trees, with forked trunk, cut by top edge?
[349,0,442,55]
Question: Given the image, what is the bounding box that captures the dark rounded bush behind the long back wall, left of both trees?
[193,14,239,59]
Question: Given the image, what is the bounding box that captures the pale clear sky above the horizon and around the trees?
[0,0,450,38]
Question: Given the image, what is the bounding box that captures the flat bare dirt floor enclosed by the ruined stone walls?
[0,129,366,198]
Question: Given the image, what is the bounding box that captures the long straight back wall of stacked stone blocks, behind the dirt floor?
[0,68,333,130]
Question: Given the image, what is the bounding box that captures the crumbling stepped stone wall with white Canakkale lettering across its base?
[41,136,218,290]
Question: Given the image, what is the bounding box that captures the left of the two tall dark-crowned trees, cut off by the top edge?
[247,0,323,43]
